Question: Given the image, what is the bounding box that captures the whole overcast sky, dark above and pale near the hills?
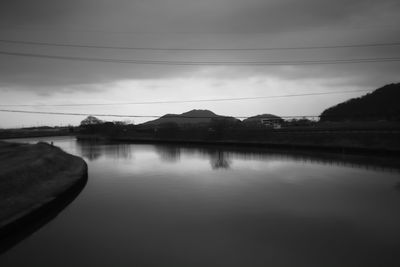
[0,0,400,128]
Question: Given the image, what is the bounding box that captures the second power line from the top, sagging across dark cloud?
[0,51,400,66]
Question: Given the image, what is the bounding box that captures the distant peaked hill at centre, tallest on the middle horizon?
[142,109,233,126]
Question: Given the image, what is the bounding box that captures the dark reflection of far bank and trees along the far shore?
[77,140,400,174]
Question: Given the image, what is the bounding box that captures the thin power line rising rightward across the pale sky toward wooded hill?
[0,89,370,107]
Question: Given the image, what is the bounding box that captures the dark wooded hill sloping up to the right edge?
[321,83,400,121]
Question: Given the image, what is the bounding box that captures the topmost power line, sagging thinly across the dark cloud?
[0,39,400,51]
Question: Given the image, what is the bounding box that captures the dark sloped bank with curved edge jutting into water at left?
[0,142,87,252]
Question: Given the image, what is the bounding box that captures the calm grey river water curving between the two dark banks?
[0,137,400,267]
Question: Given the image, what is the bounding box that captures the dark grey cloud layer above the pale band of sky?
[0,0,400,93]
